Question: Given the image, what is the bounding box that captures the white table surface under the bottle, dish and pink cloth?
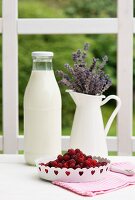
[0,155,135,200]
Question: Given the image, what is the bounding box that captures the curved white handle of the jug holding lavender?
[101,95,121,135]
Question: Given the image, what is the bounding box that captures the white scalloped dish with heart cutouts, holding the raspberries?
[36,156,110,183]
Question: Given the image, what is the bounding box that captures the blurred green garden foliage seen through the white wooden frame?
[0,0,135,139]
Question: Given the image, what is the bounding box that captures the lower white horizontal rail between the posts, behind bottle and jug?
[18,135,117,151]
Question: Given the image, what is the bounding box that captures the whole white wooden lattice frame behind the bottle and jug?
[0,0,135,155]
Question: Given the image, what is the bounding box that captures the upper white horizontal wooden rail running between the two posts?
[18,18,117,34]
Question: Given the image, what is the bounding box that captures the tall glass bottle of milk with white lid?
[24,51,61,165]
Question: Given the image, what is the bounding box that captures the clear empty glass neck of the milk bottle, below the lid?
[33,57,53,71]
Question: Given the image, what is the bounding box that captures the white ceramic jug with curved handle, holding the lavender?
[67,90,121,156]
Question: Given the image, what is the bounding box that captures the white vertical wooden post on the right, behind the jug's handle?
[117,0,133,155]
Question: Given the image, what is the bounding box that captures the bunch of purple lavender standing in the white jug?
[57,43,112,95]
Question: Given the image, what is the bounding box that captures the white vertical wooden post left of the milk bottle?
[2,0,18,153]
